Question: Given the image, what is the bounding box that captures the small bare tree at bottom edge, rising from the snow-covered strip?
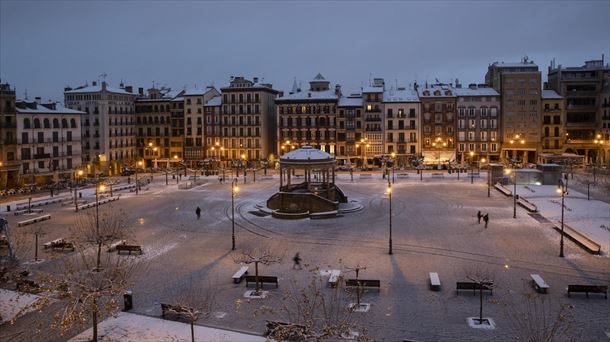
[167,279,216,342]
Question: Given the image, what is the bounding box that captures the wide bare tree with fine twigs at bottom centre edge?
[257,270,372,341]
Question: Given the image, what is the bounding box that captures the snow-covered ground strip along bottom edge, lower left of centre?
[70,312,265,342]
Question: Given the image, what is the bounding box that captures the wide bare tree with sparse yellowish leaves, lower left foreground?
[40,250,145,341]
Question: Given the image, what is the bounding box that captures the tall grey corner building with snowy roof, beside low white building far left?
[64,81,137,175]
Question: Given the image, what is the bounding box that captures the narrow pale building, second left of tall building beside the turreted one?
[182,86,220,167]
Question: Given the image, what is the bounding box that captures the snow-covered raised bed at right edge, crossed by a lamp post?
[517,185,610,254]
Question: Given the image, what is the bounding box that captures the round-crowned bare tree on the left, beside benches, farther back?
[71,205,132,270]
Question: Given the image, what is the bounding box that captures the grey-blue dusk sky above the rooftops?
[0,0,610,101]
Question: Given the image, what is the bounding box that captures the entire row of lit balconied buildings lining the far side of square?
[0,57,610,187]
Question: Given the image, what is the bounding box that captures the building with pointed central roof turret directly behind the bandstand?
[275,74,341,154]
